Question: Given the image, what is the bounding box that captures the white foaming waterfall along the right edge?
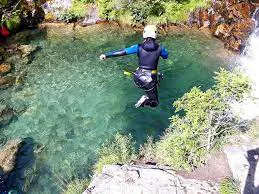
[233,8,259,120]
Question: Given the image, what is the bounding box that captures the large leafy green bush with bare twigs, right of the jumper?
[157,69,251,169]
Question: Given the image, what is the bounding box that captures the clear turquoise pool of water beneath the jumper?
[1,25,234,193]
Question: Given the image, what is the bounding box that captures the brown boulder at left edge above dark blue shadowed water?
[0,139,22,173]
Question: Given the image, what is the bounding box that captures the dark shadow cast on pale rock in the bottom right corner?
[244,148,259,194]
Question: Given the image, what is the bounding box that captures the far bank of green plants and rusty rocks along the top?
[38,0,256,53]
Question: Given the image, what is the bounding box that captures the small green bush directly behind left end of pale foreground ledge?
[95,134,136,172]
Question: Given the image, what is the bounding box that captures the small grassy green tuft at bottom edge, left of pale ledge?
[63,179,89,194]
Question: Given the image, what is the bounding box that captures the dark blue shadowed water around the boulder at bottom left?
[0,138,36,194]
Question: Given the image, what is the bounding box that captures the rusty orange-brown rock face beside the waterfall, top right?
[188,0,256,52]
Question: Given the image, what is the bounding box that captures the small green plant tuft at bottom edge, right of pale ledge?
[219,177,240,194]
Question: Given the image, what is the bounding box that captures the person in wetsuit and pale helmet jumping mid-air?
[100,25,168,108]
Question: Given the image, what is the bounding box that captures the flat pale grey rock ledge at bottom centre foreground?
[83,165,218,194]
